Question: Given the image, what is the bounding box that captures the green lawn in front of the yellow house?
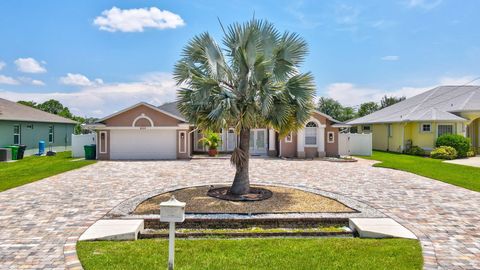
[361,151,480,191]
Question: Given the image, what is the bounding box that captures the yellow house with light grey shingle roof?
[348,86,480,153]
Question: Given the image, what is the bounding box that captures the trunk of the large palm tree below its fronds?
[230,128,250,195]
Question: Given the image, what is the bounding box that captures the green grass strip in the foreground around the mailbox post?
[77,238,423,270]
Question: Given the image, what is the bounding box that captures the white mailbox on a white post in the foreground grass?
[160,196,185,270]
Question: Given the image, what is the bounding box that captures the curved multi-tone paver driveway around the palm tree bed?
[0,159,480,269]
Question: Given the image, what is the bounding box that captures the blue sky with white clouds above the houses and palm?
[0,0,480,117]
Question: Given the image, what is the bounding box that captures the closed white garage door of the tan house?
[110,130,177,159]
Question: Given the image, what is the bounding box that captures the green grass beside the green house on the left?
[0,151,95,192]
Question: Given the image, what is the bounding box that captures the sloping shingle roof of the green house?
[0,98,77,124]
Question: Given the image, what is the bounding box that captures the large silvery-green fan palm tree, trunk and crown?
[174,19,315,195]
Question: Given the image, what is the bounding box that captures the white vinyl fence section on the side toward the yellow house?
[338,133,372,156]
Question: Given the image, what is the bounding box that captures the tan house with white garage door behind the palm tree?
[90,102,345,160]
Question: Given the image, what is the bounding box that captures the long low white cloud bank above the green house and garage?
[0,73,178,117]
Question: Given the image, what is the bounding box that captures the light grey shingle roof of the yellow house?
[348,85,480,124]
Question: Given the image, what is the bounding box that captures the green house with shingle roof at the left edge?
[0,98,76,155]
